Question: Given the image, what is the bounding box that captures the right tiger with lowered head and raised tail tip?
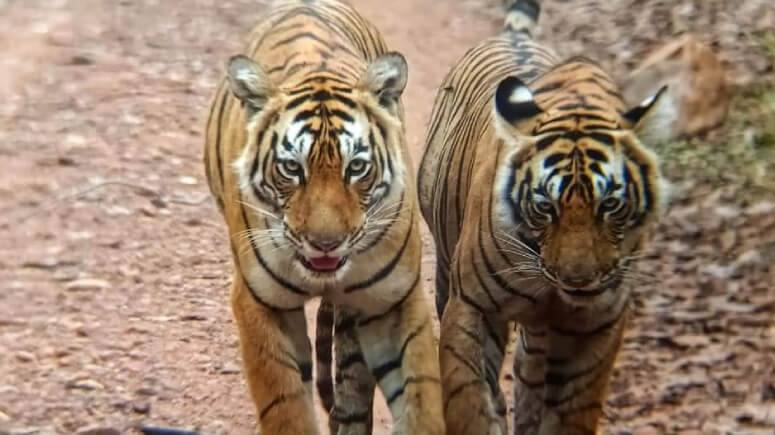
[417,0,675,435]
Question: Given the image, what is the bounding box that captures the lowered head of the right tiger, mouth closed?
[494,62,674,305]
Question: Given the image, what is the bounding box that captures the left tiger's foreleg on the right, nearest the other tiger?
[358,282,445,435]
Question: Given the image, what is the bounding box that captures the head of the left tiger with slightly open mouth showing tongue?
[228,53,407,279]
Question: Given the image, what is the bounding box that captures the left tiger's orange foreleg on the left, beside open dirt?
[231,276,318,435]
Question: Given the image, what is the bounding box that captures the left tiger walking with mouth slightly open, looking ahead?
[203,0,444,435]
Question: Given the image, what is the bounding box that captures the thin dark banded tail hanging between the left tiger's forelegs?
[315,301,334,412]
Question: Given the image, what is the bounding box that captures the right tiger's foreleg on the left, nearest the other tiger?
[439,293,506,435]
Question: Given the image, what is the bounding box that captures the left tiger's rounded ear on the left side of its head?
[226,54,276,111]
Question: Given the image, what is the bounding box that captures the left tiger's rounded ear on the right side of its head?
[360,52,409,108]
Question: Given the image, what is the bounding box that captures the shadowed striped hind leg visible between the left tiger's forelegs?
[328,307,375,435]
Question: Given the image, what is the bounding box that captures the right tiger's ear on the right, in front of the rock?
[622,86,678,145]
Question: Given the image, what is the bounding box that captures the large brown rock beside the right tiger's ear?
[624,34,732,136]
